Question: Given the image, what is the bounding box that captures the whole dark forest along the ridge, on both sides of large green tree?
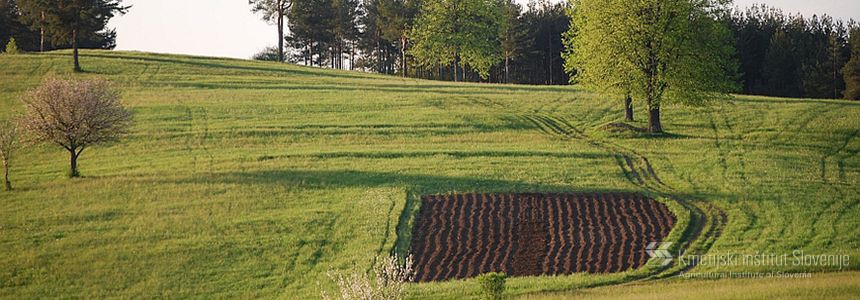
[251,0,858,98]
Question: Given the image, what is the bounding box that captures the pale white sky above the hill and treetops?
[108,0,860,58]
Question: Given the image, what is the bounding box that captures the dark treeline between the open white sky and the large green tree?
[250,0,570,84]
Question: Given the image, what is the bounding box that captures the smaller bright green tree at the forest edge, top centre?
[411,0,505,81]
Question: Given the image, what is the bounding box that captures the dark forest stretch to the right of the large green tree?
[723,5,860,98]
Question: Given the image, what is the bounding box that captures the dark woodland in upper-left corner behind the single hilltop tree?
[0,0,116,52]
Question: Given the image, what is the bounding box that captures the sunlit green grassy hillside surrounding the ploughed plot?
[0,51,860,298]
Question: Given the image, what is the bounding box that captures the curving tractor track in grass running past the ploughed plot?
[520,113,727,279]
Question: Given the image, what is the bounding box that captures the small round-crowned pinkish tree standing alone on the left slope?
[22,77,131,177]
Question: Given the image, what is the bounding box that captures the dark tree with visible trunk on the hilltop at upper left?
[18,0,129,72]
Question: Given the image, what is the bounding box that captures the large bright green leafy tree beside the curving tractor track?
[565,0,736,133]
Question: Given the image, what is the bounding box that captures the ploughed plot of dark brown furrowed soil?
[412,193,675,281]
